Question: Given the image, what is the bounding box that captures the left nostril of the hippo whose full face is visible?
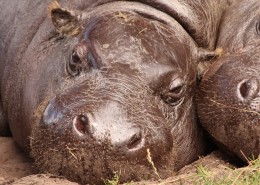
[73,115,91,136]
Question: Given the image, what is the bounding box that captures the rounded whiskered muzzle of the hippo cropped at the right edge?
[197,48,260,161]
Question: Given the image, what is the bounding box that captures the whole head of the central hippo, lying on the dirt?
[31,2,203,183]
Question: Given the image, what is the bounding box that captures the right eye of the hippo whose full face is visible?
[161,78,185,106]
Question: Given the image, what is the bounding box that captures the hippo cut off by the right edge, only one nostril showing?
[196,0,260,161]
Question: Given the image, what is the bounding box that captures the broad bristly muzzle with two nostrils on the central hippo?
[31,72,176,183]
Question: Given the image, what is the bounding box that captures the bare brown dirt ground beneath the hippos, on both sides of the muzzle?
[0,137,236,185]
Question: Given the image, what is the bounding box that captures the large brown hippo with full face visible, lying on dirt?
[0,0,225,184]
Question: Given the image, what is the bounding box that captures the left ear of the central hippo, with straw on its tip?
[48,1,81,36]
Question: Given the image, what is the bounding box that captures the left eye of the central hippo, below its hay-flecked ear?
[67,51,82,76]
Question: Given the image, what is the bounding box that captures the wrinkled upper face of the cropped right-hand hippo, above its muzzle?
[217,0,260,53]
